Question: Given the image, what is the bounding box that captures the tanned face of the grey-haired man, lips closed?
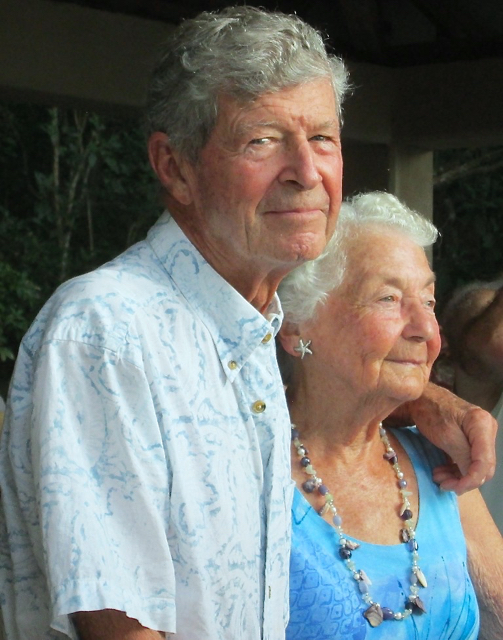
[178,79,342,289]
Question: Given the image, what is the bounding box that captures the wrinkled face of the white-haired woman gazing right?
[300,230,440,403]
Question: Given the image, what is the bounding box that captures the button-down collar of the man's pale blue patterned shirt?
[147,211,283,381]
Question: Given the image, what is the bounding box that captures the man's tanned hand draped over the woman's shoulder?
[393,382,498,495]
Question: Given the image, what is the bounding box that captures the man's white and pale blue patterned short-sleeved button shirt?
[0,213,293,640]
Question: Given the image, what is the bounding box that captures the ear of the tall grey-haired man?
[148,131,193,205]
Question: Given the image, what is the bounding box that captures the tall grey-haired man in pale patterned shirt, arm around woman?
[0,8,498,640]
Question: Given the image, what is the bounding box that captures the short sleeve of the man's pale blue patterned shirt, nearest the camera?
[31,340,175,635]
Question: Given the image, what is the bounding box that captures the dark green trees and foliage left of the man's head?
[0,104,161,370]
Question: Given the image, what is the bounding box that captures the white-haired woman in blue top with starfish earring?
[280,193,503,640]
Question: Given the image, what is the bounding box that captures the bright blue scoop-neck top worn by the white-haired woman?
[286,429,479,640]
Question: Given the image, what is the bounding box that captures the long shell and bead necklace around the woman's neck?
[292,423,428,627]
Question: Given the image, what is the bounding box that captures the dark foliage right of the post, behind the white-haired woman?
[433,148,503,308]
